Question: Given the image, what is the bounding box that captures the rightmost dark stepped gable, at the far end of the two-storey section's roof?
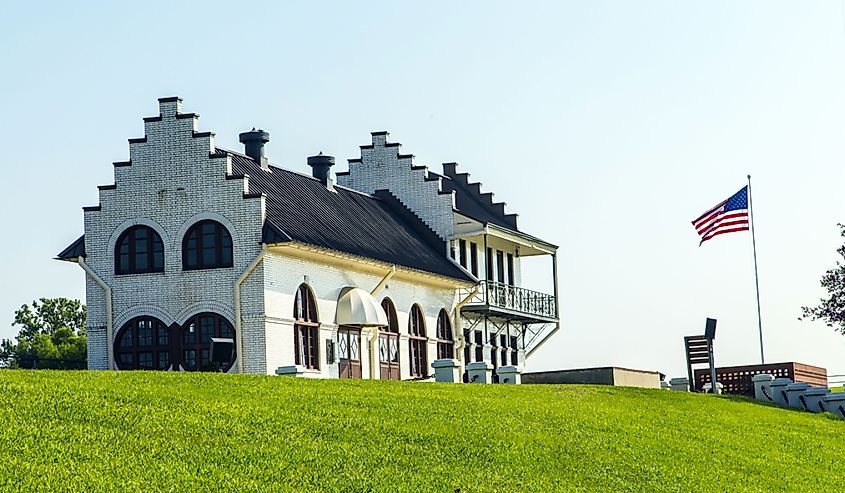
[442,163,519,231]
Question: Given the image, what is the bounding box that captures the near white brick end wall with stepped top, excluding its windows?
[80,97,264,369]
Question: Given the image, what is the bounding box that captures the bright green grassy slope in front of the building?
[0,370,845,493]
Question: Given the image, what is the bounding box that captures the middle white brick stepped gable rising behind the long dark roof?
[335,132,455,240]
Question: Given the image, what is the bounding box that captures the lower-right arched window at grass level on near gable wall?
[180,313,235,372]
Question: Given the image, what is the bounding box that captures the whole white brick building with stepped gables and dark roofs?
[58,98,558,379]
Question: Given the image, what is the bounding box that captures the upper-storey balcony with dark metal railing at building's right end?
[462,281,558,323]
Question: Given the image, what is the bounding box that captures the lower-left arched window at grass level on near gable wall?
[114,317,172,370]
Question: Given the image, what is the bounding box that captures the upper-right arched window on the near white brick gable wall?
[182,220,232,270]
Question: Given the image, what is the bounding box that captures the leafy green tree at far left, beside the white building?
[0,298,87,369]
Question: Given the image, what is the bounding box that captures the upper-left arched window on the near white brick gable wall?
[114,226,164,274]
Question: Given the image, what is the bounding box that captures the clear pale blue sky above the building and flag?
[0,0,845,376]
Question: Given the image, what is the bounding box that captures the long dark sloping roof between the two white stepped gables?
[224,149,477,283]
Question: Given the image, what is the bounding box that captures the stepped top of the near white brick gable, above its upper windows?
[57,96,262,260]
